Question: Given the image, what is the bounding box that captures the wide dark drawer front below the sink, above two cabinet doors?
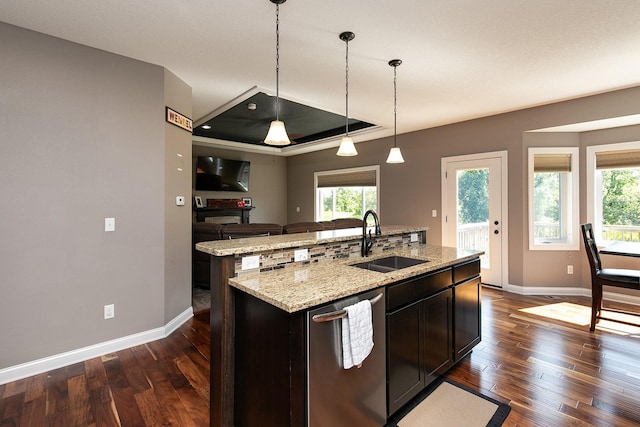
[387,268,453,311]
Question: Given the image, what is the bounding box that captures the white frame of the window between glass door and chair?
[527,147,580,251]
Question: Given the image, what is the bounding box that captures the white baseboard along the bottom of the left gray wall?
[0,307,193,385]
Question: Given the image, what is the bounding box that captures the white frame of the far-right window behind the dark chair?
[586,141,640,247]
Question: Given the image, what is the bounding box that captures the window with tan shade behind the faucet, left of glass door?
[314,166,380,221]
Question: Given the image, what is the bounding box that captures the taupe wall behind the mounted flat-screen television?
[193,145,288,225]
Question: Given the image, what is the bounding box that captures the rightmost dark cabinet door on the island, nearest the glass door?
[453,277,482,361]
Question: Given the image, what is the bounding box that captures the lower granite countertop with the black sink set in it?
[229,244,482,313]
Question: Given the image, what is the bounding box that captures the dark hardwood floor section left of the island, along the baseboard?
[0,312,210,427]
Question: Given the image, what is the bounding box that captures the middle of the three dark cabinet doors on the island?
[422,289,453,384]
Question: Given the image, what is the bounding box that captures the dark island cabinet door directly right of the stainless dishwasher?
[387,301,424,415]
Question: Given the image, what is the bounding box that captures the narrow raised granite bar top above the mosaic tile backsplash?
[196,225,428,256]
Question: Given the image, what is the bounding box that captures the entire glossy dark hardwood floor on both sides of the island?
[0,289,640,427]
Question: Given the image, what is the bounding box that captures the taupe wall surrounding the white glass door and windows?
[287,87,640,287]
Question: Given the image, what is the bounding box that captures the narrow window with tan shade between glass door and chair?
[529,147,580,250]
